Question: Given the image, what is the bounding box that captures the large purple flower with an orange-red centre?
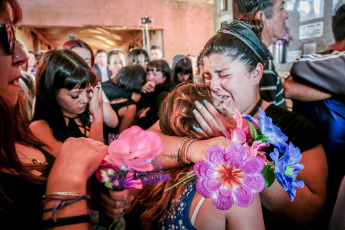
[194,144,265,210]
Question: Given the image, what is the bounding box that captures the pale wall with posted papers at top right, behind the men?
[273,0,345,76]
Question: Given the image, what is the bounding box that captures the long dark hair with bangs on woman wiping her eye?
[33,49,96,142]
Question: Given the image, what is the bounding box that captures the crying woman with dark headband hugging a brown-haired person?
[152,21,327,229]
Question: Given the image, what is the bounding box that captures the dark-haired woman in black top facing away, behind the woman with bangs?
[102,65,145,141]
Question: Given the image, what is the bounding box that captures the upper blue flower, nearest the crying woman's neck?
[259,108,288,153]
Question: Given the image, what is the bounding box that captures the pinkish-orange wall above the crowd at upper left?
[18,0,214,62]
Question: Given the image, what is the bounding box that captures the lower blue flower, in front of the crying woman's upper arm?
[270,143,304,201]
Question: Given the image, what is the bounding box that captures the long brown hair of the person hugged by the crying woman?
[131,83,212,229]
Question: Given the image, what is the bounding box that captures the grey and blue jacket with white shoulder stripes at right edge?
[291,50,345,227]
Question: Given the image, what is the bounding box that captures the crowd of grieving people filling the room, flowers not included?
[0,0,345,230]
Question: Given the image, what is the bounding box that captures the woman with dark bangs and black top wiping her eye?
[30,49,103,155]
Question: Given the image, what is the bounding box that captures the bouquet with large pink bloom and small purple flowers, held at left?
[96,126,170,190]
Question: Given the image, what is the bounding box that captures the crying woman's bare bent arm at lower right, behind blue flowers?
[260,144,328,226]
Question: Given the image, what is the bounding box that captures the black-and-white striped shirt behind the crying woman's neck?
[259,59,286,108]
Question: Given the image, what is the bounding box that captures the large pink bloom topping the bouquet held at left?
[104,126,163,172]
